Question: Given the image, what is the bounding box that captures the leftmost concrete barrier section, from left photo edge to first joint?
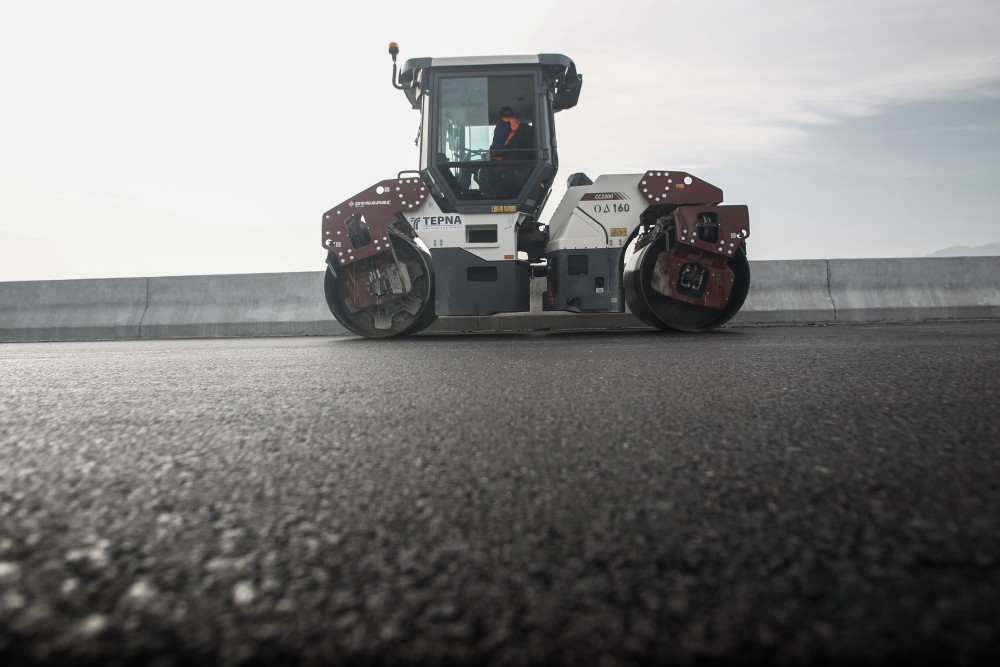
[0,278,149,342]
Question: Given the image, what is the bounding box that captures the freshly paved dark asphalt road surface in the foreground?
[0,322,1000,666]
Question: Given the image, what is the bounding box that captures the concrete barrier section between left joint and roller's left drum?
[141,271,347,338]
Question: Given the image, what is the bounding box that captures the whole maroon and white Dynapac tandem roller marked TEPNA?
[322,44,750,338]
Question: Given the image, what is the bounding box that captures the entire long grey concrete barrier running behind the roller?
[0,257,1000,342]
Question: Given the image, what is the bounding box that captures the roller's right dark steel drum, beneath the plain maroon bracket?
[622,236,750,332]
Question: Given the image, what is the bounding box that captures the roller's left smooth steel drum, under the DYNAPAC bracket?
[324,234,437,338]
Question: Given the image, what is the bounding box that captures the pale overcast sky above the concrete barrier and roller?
[0,0,1000,280]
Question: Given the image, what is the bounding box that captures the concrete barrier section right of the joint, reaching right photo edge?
[829,257,1000,322]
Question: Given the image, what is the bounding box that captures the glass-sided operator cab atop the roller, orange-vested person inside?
[390,51,582,216]
